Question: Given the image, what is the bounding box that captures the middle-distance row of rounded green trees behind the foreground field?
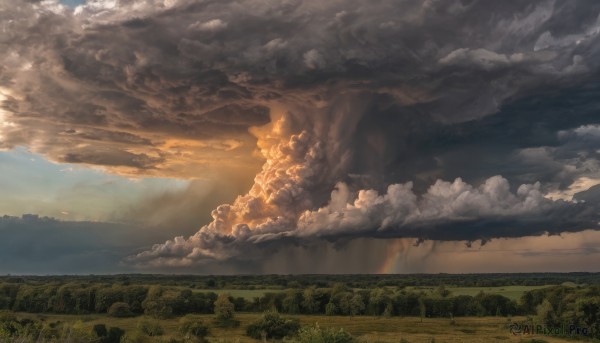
[0,283,522,318]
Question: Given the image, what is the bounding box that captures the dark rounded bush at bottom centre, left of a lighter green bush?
[246,311,300,339]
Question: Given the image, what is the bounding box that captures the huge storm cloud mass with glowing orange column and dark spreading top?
[0,0,600,265]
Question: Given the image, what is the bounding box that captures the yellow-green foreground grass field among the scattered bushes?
[21,313,574,343]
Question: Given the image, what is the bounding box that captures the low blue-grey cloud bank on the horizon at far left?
[0,216,150,274]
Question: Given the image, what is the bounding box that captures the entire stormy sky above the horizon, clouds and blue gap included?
[0,0,600,274]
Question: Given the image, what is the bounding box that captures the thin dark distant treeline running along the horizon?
[0,272,600,290]
